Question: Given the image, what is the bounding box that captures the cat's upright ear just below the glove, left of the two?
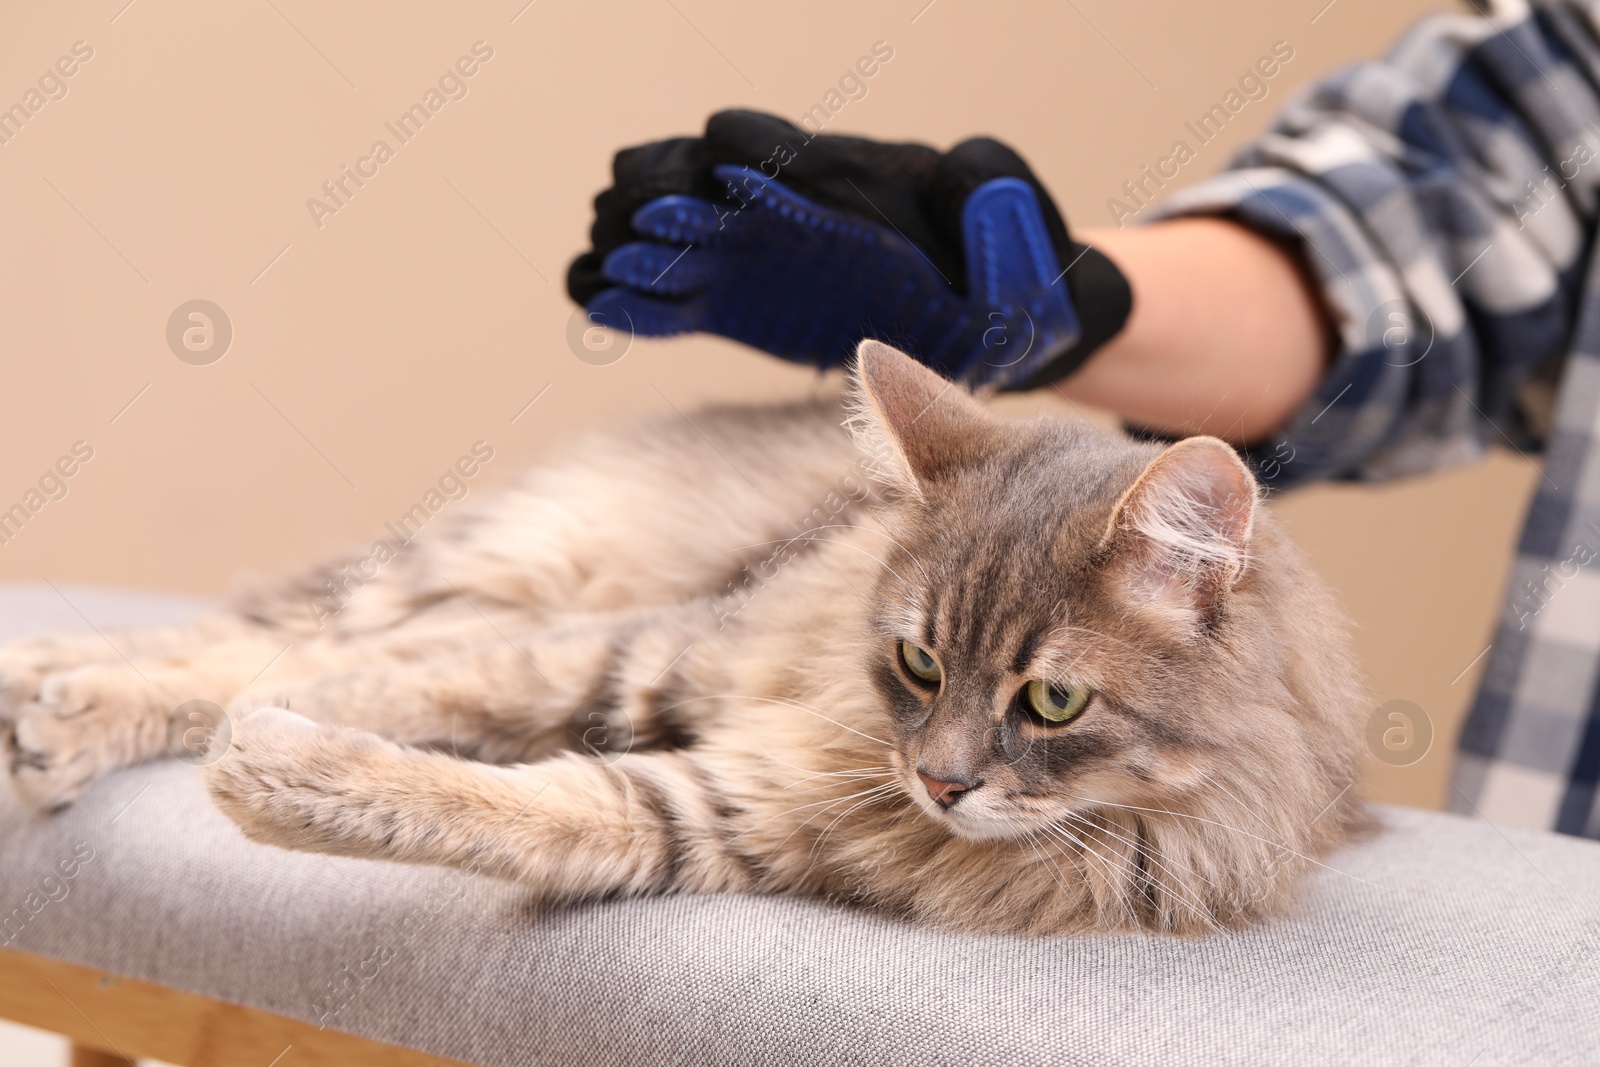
[846,341,1000,499]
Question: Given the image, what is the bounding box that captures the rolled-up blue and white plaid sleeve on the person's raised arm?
[1160,0,1600,486]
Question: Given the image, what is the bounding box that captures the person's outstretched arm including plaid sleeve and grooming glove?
[570,0,1600,485]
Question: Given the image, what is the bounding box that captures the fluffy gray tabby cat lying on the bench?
[0,342,1370,934]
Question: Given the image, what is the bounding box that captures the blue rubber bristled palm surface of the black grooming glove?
[589,165,1082,384]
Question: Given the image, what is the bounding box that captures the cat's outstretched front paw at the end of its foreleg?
[202,707,395,854]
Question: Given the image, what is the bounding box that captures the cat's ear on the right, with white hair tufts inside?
[1106,437,1259,630]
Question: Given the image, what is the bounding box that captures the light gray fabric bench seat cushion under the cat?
[0,590,1600,1067]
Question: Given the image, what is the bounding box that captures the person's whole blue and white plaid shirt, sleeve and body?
[1162,0,1600,837]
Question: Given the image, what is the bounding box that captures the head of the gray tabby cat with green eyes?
[851,342,1366,921]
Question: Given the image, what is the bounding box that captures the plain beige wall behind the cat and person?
[0,0,1533,805]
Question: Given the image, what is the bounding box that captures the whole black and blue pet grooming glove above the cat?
[568,112,1130,387]
